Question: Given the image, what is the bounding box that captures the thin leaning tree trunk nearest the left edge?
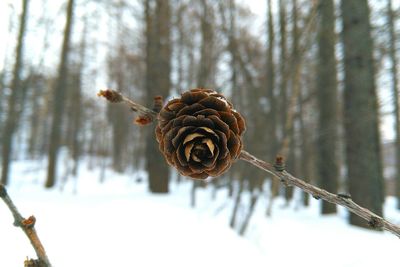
[1,0,28,185]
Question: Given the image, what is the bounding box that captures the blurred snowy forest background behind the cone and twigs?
[0,0,400,266]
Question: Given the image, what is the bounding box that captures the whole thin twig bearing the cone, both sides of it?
[98,90,400,238]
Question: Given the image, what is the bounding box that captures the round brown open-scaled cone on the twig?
[156,89,245,179]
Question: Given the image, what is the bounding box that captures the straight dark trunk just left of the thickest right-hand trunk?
[316,0,339,214]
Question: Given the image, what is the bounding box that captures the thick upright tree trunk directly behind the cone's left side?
[144,0,171,193]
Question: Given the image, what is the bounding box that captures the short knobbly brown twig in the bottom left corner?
[0,184,51,267]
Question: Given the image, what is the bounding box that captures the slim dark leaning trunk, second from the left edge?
[45,0,74,188]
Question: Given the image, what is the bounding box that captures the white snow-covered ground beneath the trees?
[0,162,400,267]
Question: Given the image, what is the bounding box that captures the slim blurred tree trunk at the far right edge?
[387,0,400,209]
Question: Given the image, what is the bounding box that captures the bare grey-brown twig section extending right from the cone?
[239,150,400,238]
